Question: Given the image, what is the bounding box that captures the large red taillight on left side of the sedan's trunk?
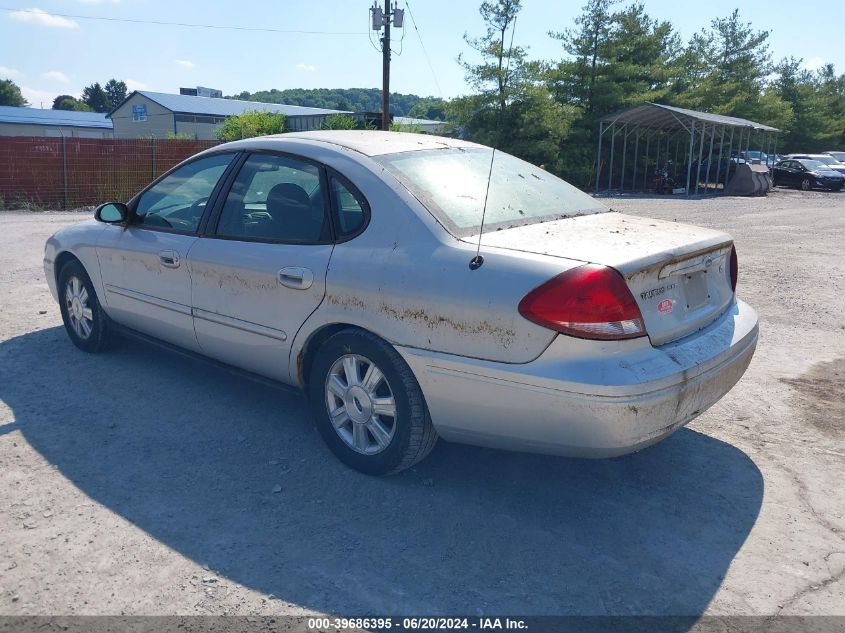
[519,264,646,340]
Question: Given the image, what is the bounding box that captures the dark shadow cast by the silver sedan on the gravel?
[0,328,763,615]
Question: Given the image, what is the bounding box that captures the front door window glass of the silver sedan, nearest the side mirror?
[133,154,232,233]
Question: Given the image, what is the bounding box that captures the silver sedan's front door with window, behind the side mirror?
[97,153,239,351]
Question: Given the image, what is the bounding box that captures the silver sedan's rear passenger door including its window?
[188,153,340,382]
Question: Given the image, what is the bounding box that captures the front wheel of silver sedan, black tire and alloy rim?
[59,260,110,353]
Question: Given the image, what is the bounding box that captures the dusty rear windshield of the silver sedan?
[375,148,608,237]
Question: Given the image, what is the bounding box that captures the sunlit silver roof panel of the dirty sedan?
[231,130,483,156]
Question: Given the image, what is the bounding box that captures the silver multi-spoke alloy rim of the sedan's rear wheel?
[325,354,396,455]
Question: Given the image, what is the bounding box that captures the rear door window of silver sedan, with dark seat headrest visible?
[217,154,331,243]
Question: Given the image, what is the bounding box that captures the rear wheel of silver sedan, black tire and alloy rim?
[308,329,437,475]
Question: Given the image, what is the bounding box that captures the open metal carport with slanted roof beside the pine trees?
[595,103,780,195]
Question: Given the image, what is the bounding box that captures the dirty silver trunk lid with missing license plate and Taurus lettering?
[478,212,733,345]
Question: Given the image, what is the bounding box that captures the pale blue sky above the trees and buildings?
[0,0,845,107]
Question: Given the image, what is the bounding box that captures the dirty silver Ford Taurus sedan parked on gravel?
[44,131,758,474]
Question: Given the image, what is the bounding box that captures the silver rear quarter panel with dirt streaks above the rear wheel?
[291,146,575,382]
